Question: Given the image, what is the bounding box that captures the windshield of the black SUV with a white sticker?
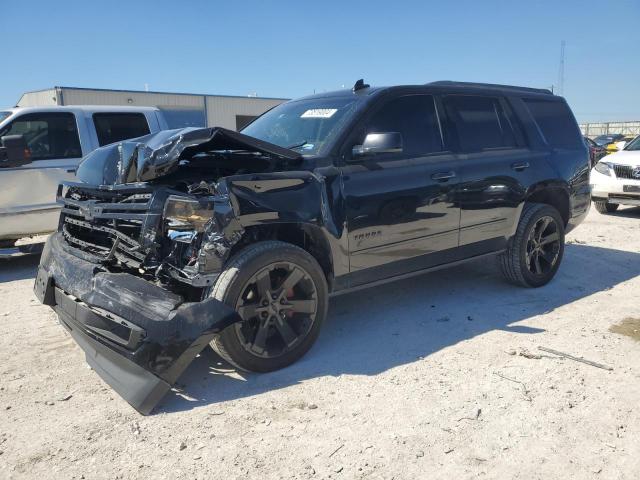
[242,97,358,155]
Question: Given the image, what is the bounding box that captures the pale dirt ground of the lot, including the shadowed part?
[0,209,640,480]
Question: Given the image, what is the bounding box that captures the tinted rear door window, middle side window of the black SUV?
[444,95,517,152]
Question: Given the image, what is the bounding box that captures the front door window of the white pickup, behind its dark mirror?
[0,113,82,160]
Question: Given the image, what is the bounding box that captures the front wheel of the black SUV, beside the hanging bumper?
[210,241,328,372]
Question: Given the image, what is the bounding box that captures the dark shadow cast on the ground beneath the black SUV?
[157,244,640,412]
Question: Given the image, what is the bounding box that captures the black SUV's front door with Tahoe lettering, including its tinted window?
[342,94,460,285]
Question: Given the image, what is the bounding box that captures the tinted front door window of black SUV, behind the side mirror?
[363,95,442,157]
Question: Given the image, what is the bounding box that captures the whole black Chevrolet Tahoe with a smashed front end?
[35,80,590,414]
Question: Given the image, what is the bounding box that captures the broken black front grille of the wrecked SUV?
[59,184,163,268]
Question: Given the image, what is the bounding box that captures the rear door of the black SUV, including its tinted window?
[442,95,543,251]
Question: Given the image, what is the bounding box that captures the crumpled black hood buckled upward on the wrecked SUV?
[77,127,302,185]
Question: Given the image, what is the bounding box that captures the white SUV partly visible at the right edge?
[590,137,640,213]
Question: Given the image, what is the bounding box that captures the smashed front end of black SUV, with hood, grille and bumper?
[34,128,318,414]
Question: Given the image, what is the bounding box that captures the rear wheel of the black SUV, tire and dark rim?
[498,203,564,288]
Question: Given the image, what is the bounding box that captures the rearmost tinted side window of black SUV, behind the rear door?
[523,99,582,148]
